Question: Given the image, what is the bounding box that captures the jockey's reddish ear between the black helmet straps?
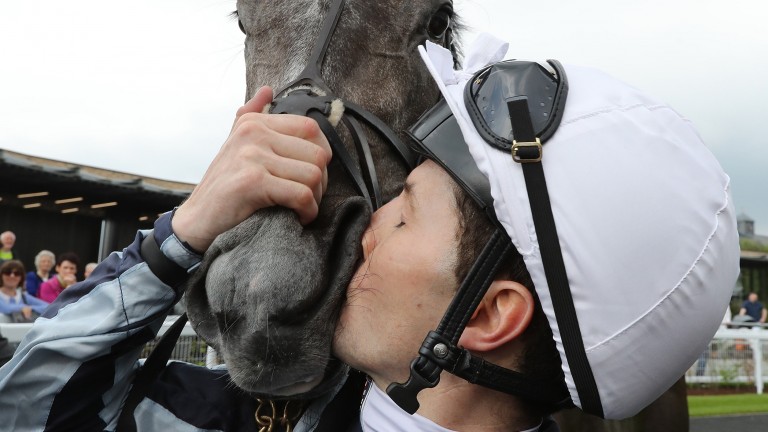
[459,280,534,352]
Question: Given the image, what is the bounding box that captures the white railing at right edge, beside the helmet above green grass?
[685,325,768,394]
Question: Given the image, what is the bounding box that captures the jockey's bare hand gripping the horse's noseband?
[172,87,331,251]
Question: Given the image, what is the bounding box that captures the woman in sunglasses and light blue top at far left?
[0,260,48,322]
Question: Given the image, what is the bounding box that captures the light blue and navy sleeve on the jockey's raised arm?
[0,213,201,431]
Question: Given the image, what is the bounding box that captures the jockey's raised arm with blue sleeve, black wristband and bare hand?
[0,89,330,430]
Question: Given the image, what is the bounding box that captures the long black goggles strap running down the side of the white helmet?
[507,98,603,417]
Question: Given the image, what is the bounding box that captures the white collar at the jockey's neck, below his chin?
[360,383,540,432]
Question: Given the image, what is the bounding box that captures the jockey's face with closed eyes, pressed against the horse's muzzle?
[334,162,458,388]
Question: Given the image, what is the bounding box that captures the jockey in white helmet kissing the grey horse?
[0,37,739,432]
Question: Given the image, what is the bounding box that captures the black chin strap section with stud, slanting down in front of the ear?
[387,228,512,414]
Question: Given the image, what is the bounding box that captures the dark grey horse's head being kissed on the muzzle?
[186,0,458,397]
